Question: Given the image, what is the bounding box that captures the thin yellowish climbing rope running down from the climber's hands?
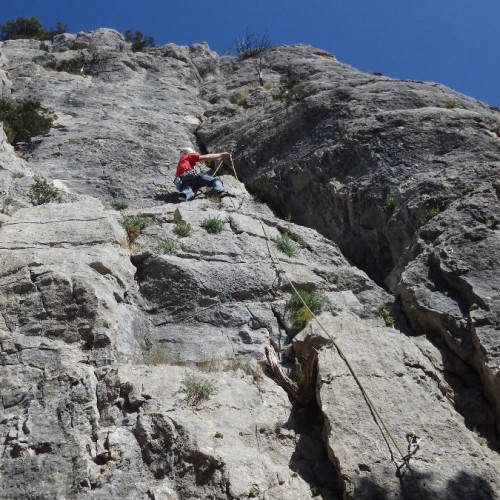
[229,155,426,499]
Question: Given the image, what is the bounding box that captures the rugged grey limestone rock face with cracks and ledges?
[0,29,500,500]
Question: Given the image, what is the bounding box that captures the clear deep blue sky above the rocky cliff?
[0,0,500,106]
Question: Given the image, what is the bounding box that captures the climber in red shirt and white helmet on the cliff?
[174,148,229,200]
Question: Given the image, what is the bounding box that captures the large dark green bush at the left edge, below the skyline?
[0,99,54,144]
